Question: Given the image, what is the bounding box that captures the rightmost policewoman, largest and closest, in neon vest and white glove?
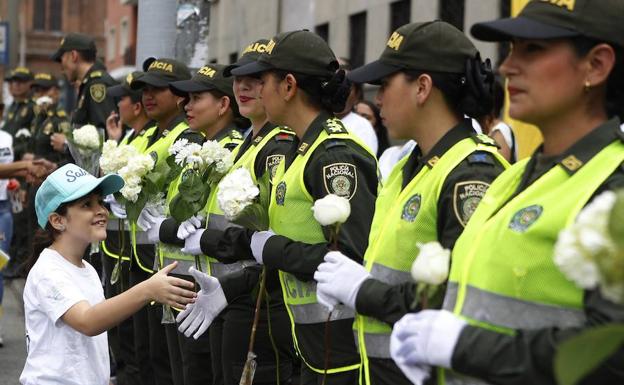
[392,0,624,385]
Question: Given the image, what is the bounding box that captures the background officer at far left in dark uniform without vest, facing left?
[51,33,116,135]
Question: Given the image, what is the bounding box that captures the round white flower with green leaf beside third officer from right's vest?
[217,168,270,231]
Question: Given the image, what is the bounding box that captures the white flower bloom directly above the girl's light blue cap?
[67,124,104,175]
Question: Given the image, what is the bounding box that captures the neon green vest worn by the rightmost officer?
[439,140,624,384]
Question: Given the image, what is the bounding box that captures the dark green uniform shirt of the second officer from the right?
[355,120,504,325]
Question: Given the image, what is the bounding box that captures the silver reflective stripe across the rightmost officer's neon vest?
[444,282,585,329]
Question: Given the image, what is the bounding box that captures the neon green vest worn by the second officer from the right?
[355,136,507,384]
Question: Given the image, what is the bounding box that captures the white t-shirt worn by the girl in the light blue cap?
[20,249,110,385]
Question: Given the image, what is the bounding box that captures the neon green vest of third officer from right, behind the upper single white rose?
[269,119,374,373]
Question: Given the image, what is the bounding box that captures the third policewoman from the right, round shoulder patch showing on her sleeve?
[178,31,378,384]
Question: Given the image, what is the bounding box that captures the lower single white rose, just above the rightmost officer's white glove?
[412,242,451,285]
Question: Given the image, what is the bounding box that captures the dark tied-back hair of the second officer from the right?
[460,52,494,119]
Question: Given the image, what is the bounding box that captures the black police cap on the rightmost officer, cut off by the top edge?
[470,0,624,47]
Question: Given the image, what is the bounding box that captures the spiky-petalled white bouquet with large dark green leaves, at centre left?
[167,139,233,222]
